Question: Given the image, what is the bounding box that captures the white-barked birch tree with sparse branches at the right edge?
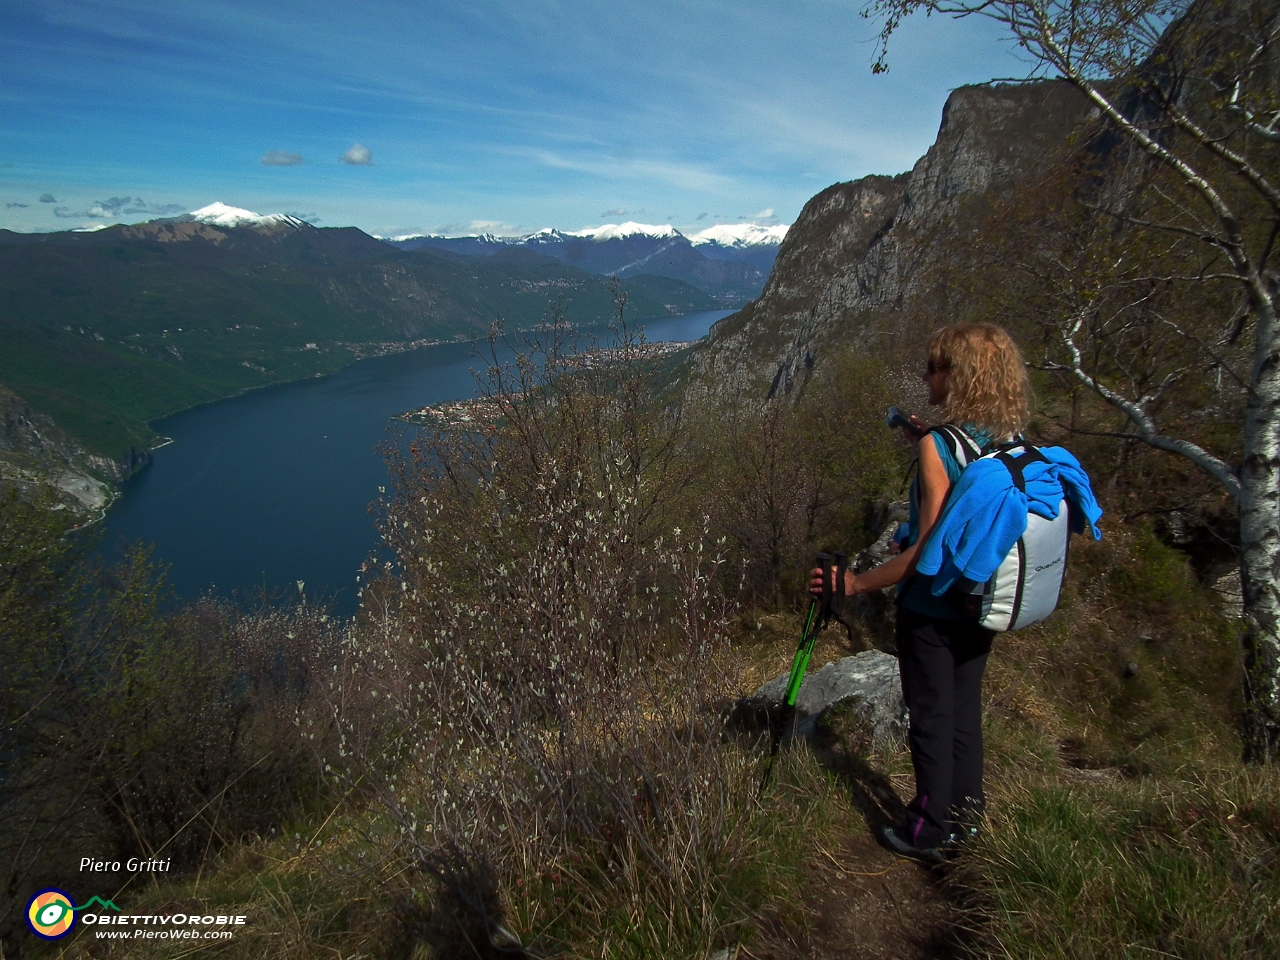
[864,0,1280,763]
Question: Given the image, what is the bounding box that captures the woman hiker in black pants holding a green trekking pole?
[810,324,1032,863]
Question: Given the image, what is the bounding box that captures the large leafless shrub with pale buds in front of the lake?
[333,305,788,955]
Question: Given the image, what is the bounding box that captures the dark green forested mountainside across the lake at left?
[0,229,716,457]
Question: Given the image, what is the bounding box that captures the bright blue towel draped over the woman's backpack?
[915,447,1102,596]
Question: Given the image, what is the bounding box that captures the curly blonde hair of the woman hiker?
[927,324,1032,439]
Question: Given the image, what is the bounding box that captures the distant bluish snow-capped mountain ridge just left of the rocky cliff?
[384,221,787,306]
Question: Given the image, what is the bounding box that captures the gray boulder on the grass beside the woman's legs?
[746,650,908,744]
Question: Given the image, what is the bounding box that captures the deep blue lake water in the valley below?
[102,310,731,616]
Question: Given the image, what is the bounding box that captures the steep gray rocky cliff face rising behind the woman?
[692,82,1089,394]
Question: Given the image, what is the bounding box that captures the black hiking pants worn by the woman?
[896,607,995,849]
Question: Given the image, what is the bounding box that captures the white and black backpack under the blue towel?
[931,424,1071,632]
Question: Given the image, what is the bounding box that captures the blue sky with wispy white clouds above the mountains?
[0,0,1025,236]
